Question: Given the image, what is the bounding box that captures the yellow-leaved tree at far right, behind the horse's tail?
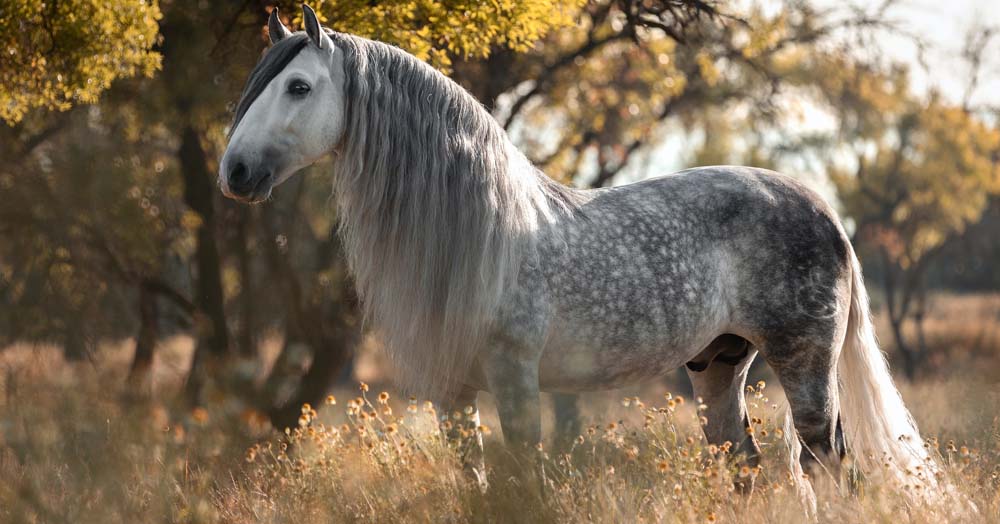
[833,95,1000,378]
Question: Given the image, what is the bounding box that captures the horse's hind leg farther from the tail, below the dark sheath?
[687,335,760,478]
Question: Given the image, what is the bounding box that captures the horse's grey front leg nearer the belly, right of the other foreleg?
[483,345,542,452]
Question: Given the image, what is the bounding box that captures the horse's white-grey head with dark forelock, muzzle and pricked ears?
[219,6,345,202]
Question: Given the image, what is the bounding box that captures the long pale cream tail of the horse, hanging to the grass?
[840,249,938,487]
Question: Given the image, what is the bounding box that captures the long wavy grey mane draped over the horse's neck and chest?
[330,33,573,398]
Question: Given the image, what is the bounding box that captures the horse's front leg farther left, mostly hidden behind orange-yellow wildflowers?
[441,386,488,492]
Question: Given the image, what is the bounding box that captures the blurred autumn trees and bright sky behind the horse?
[0,0,1000,438]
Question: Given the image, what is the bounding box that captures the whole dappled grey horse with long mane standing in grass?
[219,6,929,502]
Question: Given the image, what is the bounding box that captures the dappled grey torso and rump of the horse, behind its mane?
[527,167,846,389]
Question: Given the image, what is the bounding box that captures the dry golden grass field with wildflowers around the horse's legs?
[0,296,1000,523]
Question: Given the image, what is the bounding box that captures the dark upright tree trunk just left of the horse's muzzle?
[178,124,229,404]
